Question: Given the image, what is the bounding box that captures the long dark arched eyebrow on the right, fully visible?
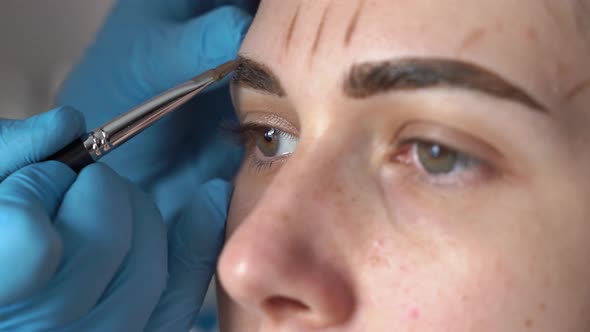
[343,58,547,112]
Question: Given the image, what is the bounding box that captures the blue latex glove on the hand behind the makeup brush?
[58,0,258,222]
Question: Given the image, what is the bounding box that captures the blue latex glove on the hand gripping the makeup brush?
[0,108,229,331]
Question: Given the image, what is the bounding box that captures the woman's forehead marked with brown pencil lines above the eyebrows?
[242,0,588,104]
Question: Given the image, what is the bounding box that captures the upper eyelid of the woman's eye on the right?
[396,121,504,164]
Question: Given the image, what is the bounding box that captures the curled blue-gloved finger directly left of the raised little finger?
[64,178,168,332]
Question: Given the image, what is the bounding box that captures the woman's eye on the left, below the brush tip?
[254,128,298,158]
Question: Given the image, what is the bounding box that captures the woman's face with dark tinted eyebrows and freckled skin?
[218,0,590,332]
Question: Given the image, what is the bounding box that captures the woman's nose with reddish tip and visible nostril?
[218,147,355,330]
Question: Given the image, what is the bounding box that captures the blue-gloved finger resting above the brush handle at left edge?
[0,107,85,181]
